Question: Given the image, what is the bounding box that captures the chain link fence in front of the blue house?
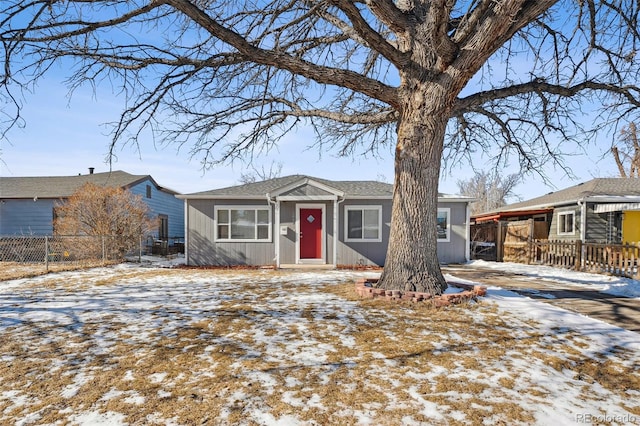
[0,235,145,280]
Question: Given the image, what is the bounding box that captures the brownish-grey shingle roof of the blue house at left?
[0,170,174,198]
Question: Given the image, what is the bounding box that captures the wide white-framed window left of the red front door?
[216,207,271,241]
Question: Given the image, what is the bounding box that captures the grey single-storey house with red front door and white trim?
[178,175,473,267]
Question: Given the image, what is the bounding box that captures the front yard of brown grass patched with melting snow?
[0,266,640,425]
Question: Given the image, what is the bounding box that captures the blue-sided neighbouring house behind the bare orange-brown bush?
[0,169,184,243]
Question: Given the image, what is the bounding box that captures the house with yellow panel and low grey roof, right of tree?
[472,178,640,243]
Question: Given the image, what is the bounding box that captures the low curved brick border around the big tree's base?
[356,278,487,308]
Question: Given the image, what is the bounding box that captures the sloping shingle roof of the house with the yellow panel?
[498,178,640,211]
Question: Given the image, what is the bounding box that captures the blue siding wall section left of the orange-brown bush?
[0,199,54,236]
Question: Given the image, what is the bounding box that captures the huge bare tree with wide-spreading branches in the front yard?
[0,0,640,294]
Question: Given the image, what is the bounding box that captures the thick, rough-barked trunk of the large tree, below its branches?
[378,98,448,295]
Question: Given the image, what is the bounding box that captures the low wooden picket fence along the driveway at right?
[521,240,640,279]
